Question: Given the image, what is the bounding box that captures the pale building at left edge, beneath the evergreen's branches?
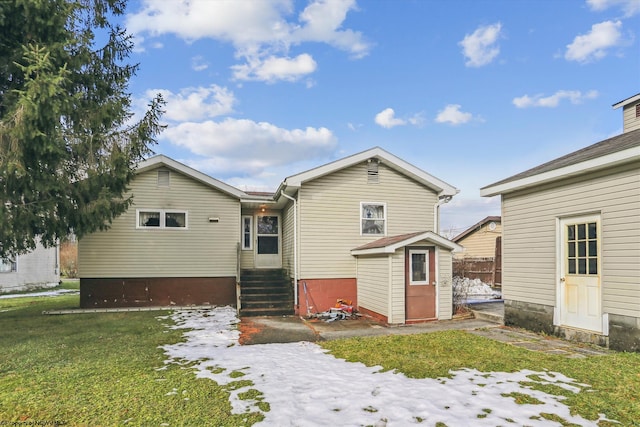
[0,244,60,293]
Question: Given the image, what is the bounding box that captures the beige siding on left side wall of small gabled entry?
[357,255,391,316]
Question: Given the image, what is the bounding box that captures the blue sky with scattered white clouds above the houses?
[123,0,640,235]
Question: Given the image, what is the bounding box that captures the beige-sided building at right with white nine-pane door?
[480,94,640,351]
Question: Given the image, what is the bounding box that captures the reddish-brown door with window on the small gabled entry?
[405,248,437,321]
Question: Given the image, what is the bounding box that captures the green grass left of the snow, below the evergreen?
[0,292,263,426]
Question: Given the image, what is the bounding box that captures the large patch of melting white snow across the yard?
[160,307,608,427]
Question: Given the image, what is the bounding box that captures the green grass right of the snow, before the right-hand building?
[320,331,640,426]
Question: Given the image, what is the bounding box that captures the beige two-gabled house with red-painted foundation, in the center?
[79,147,461,324]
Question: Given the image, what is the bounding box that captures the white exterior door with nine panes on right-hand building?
[558,215,603,333]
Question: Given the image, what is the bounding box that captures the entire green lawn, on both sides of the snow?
[0,284,640,426]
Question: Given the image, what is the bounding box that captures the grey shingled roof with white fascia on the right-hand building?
[480,129,640,196]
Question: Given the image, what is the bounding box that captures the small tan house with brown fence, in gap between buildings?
[451,216,502,286]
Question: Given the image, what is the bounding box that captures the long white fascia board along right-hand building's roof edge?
[480,147,640,197]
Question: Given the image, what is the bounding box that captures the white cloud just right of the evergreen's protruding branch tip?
[146,85,236,121]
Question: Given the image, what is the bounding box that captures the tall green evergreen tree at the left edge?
[0,0,164,257]
